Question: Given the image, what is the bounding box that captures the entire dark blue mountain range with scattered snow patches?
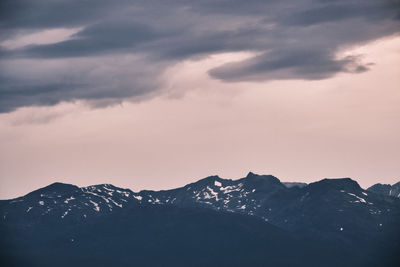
[0,175,400,266]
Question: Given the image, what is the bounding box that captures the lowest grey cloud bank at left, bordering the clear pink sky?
[0,55,165,113]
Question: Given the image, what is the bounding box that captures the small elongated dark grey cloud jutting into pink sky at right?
[210,50,368,81]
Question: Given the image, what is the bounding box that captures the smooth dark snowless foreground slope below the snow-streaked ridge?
[1,205,355,266]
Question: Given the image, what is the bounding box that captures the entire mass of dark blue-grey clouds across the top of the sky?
[0,0,400,112]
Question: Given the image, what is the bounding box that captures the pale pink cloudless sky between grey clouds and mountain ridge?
[0,35,400,199]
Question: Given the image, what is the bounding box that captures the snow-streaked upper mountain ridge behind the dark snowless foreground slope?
[1,172,400,241]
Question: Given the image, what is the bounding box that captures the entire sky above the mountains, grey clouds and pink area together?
[0,0,400,199]
